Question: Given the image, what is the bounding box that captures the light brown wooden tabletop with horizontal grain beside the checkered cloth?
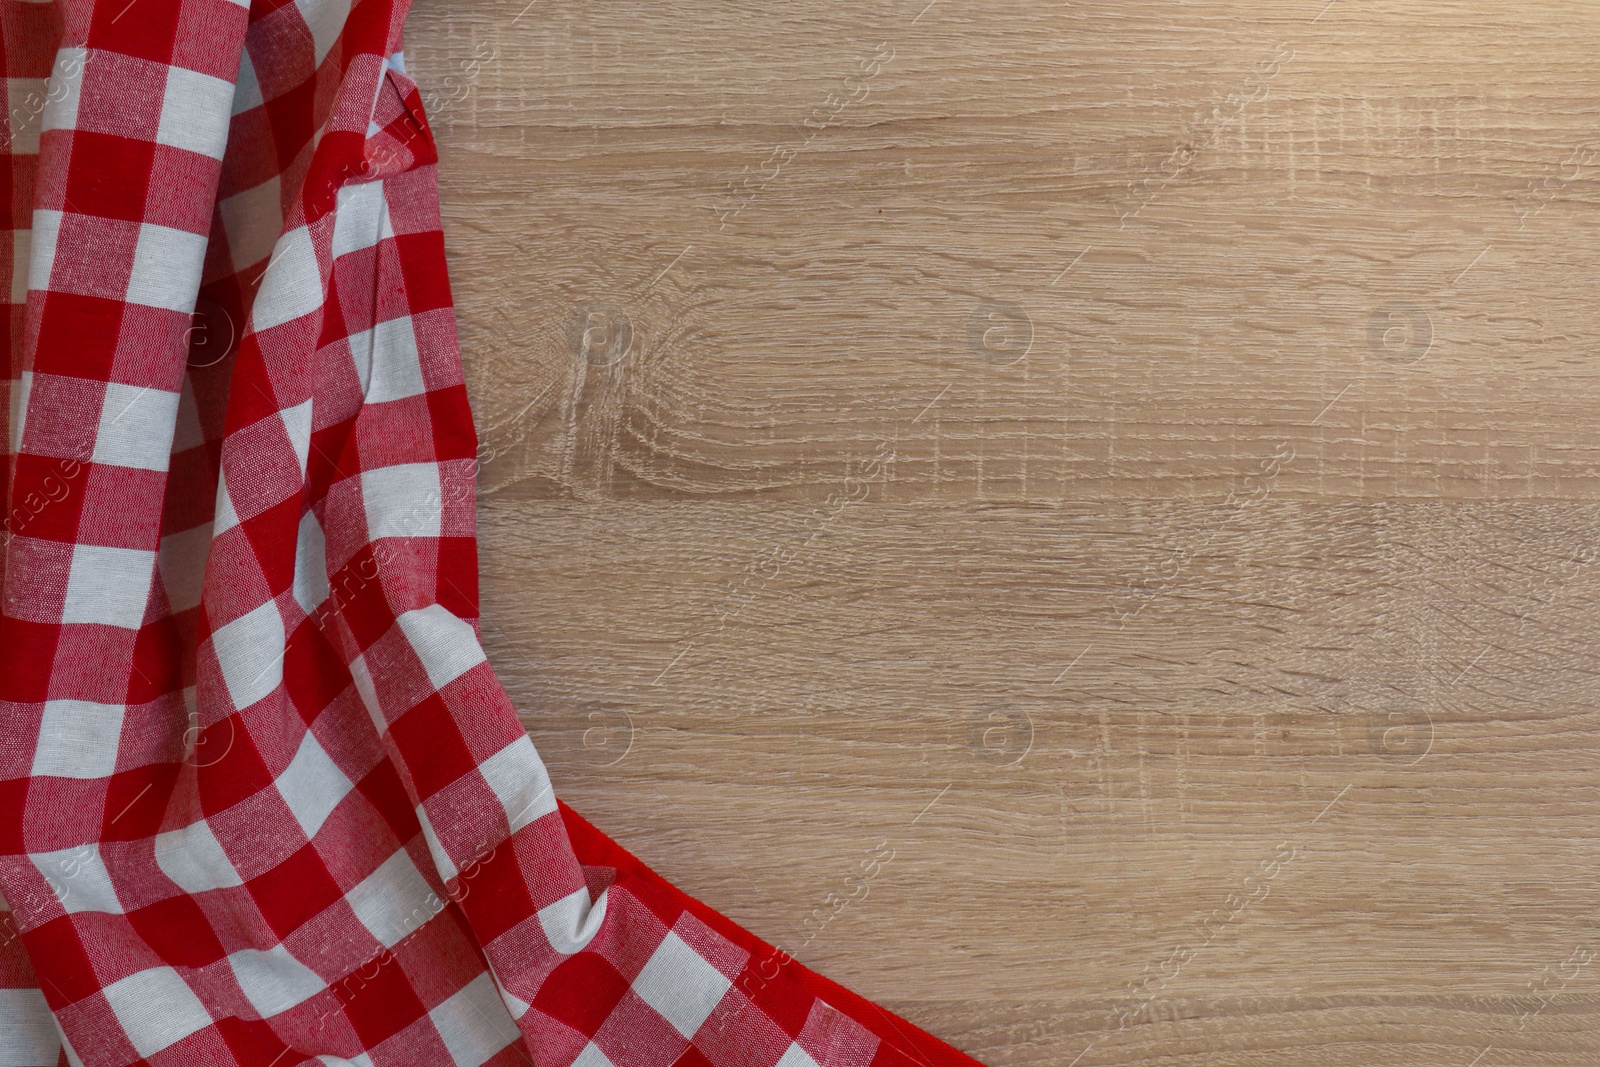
[408,0,1600,1067]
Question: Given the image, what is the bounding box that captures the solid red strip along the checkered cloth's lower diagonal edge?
[555,798,984,1067]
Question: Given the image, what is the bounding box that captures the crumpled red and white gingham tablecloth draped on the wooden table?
[0,0,974,1067]
